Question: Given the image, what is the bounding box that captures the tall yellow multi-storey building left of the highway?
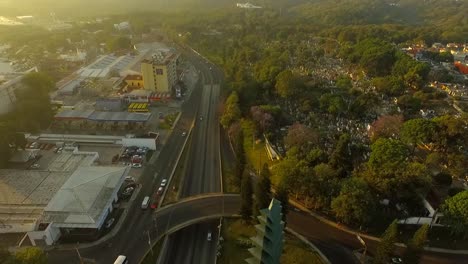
[141,52,178,93]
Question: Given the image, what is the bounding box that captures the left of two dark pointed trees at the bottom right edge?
[372,220,398,264]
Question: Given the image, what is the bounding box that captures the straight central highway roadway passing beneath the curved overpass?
[161,47,222,264]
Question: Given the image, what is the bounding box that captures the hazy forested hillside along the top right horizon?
[290,0,468,27]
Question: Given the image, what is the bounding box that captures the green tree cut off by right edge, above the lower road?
[442,191,468,238]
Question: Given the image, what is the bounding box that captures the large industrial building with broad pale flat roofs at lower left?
[0,146,130,245]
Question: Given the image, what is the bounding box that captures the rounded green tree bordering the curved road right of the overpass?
[331,177,376,226]
